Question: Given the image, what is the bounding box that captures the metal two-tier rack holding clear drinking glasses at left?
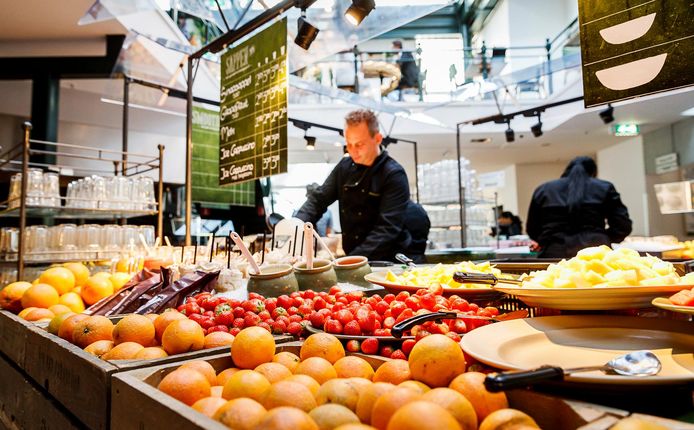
[0,122,164,281]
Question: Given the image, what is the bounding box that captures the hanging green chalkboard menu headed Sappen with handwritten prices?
[219,18,287,185]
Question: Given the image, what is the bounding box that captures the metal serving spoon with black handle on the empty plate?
[484,351,662,391]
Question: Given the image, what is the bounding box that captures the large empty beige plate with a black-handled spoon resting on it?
[460,315,694,385]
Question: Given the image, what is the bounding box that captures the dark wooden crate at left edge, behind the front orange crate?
[0,311,293,429]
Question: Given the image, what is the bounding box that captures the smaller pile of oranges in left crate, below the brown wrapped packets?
[48,309,234,361]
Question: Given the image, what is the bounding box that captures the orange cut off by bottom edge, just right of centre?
[387,400,461,430]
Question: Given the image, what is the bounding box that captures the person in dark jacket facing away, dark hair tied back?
[527,157,631,258]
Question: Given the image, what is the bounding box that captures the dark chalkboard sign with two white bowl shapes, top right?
[578,0,694,107]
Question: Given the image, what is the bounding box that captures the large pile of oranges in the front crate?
[158,327,538,430]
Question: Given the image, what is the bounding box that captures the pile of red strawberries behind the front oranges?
[178,286,499,358]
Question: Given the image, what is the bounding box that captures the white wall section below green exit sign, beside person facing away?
[596,136,648,236]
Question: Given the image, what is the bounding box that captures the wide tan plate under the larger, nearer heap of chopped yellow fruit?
[492,283,692,311]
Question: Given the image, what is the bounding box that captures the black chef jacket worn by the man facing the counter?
[296,151,411,260]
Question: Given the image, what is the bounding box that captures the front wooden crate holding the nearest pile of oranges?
[111,342,687,430]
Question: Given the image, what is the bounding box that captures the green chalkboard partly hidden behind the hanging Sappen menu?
[192,106,255,208]
